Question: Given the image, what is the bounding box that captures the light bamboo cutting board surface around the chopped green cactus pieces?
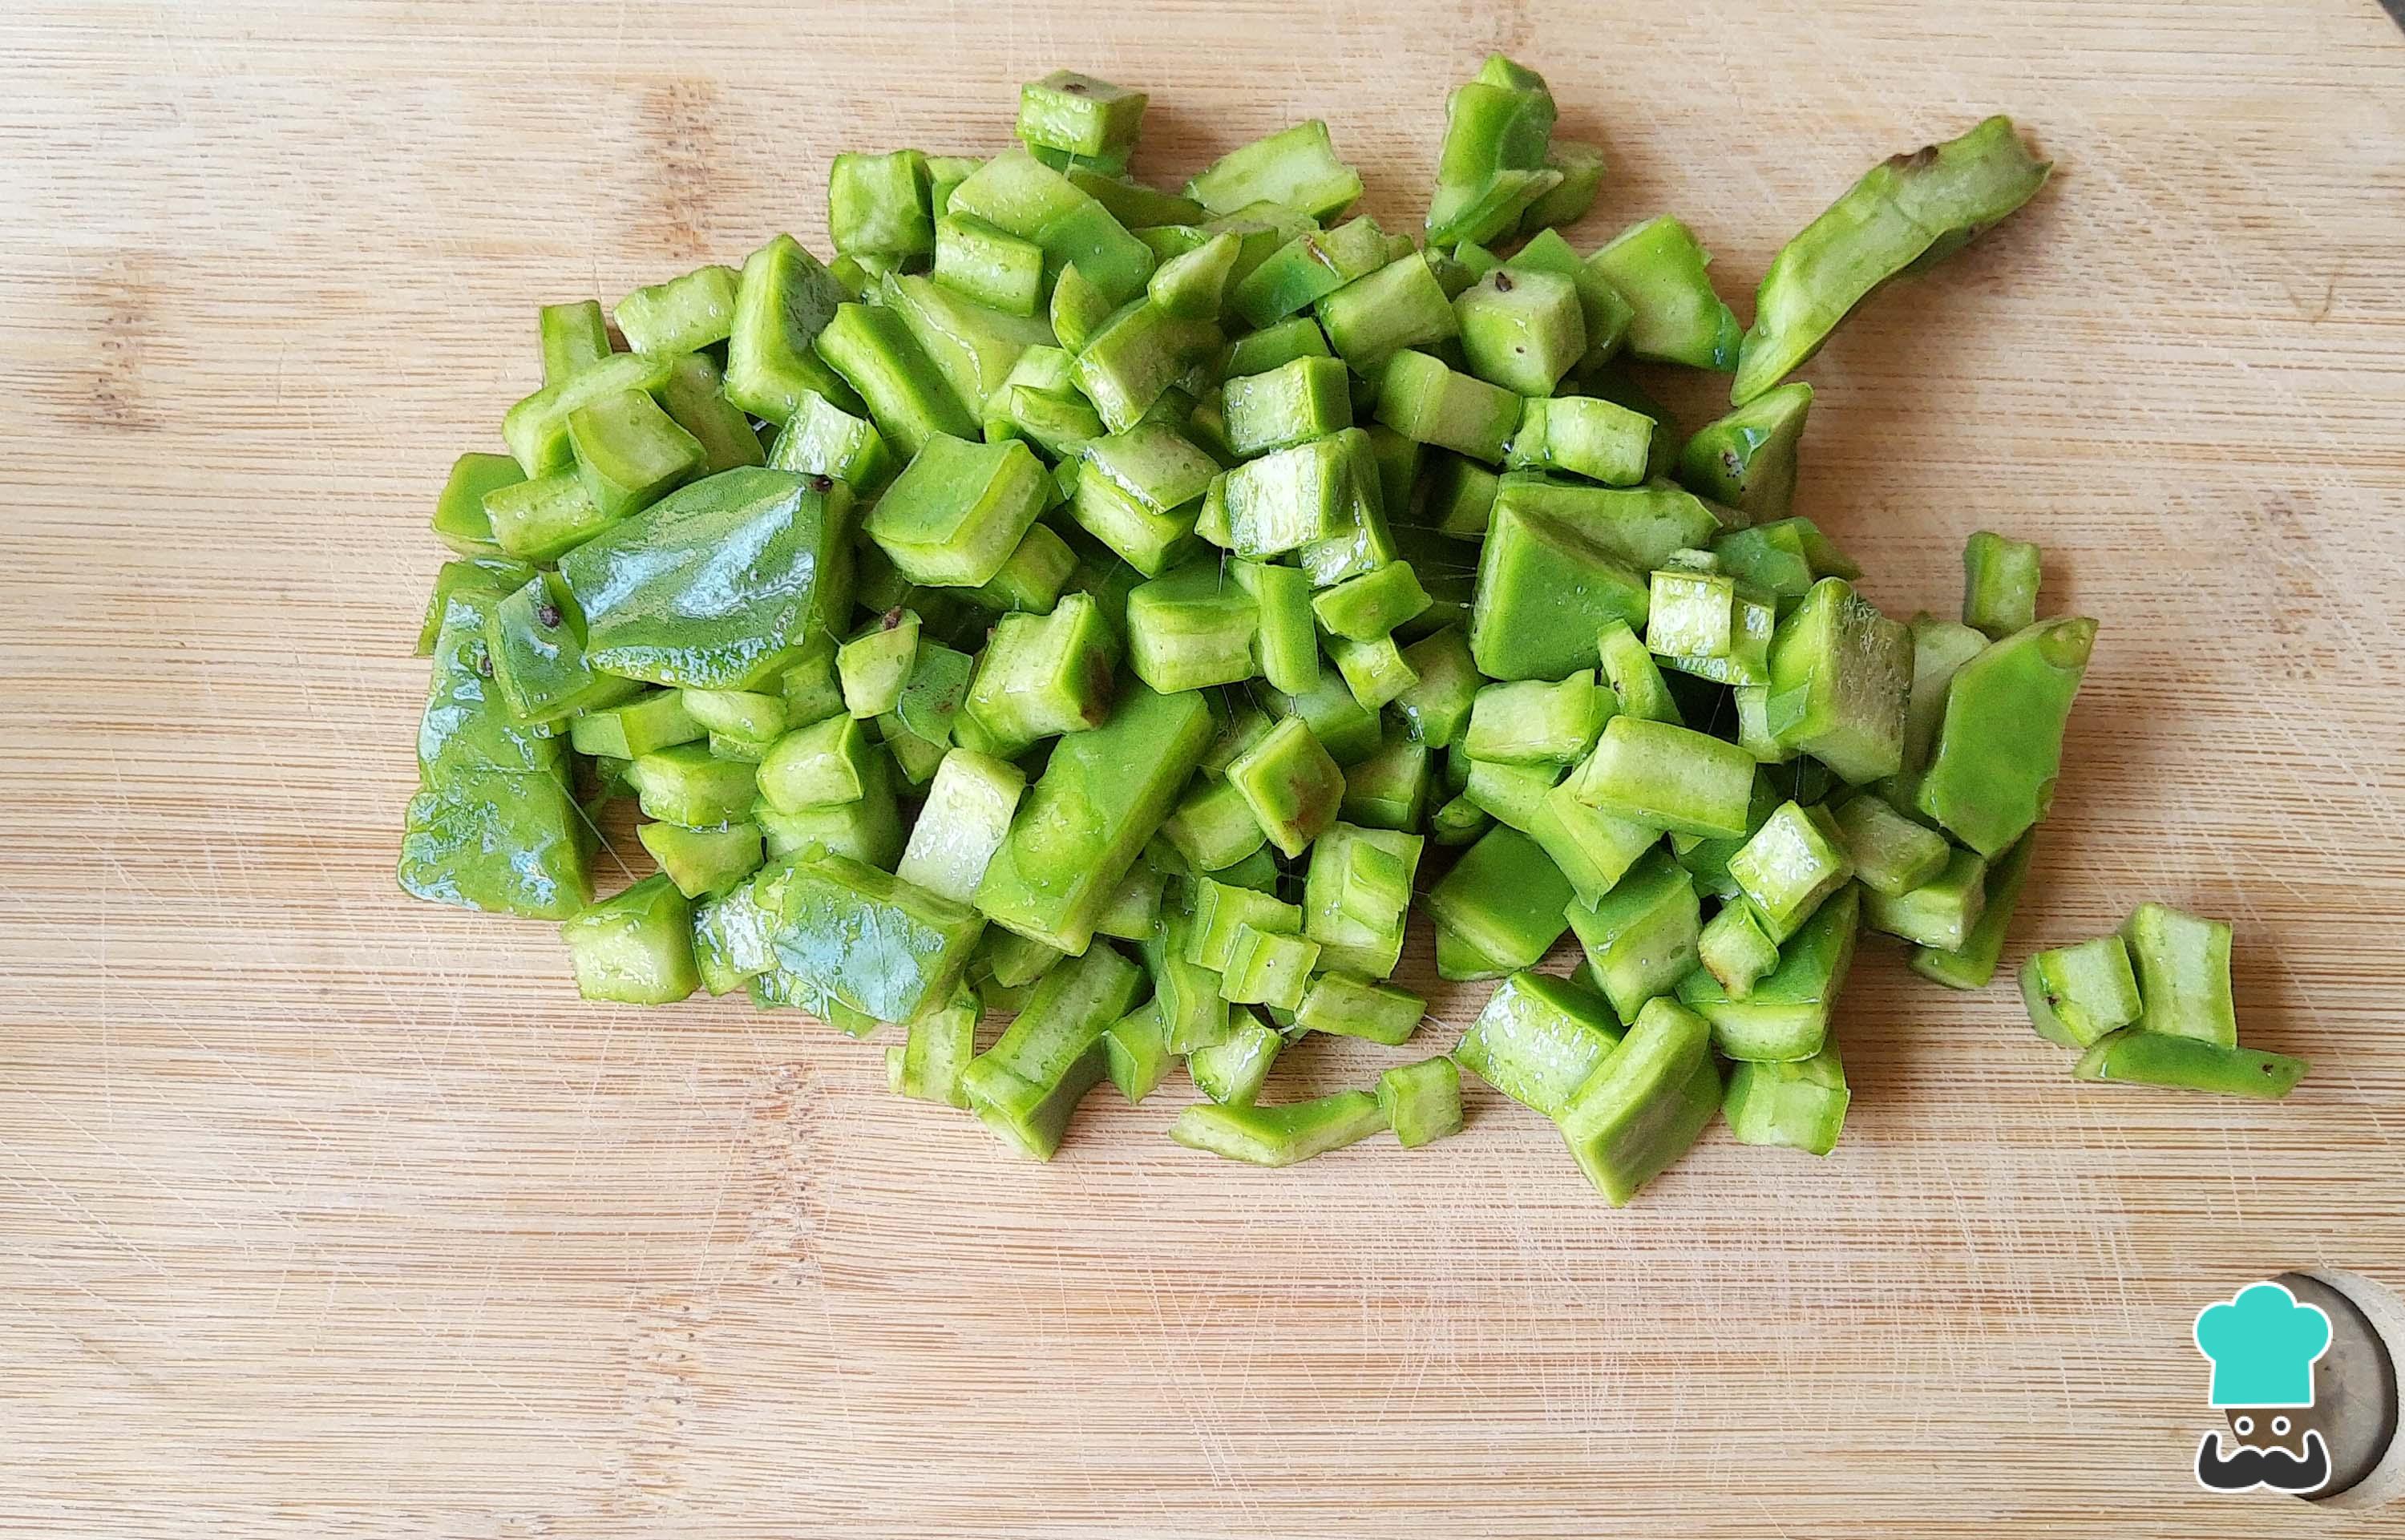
[0,0,2405,1538]
